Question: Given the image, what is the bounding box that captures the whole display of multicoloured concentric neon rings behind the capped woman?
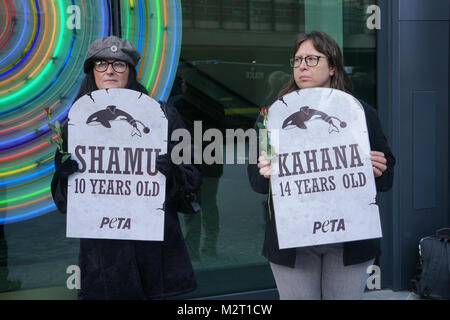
[0,0,181,224]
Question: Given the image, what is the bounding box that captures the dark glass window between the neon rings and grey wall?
[172,0,376,296]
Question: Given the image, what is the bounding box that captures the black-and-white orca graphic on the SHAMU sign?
[86,106,150,137]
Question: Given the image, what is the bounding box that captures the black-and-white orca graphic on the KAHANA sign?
[282,106,347,133]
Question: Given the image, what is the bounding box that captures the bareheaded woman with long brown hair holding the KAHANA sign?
[248,31,395,300]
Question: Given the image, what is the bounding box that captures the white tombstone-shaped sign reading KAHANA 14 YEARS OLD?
[267,88,382,249]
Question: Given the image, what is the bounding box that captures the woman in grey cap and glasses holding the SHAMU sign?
[51,36,201,300]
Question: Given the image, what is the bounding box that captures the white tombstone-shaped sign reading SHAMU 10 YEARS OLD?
[67,89,168,241]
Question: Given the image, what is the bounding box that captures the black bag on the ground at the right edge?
[412,228,450,299]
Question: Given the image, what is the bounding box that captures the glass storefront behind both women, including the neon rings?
[0,0,377,299]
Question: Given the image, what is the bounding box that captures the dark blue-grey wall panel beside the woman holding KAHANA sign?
[378,0,450,290]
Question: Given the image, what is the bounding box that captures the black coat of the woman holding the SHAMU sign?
[51,106,201,299]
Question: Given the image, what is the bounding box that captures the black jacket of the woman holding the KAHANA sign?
[247,101,395,268]
